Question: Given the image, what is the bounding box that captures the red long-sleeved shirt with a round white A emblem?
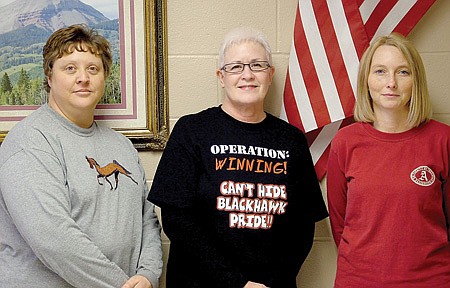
[327,121,450,288]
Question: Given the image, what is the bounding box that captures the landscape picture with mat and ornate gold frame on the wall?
[0,0,169,150]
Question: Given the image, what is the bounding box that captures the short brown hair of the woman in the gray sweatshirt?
[42,24,112,92]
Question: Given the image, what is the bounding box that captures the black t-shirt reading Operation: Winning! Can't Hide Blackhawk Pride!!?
[149,107,328,288]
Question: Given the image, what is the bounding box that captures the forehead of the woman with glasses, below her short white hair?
[224,41,267,62]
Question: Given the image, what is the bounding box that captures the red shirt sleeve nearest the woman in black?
[327,145,347,246]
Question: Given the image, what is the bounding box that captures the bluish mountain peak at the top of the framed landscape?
[0,0,109,34]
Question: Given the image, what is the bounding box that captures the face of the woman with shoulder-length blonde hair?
[367,45,413,115]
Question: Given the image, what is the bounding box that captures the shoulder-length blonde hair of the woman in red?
[353,33,433,127]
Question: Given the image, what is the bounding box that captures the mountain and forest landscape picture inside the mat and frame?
[0,0,122,108]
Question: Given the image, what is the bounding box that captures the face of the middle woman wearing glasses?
[217,41,275,111]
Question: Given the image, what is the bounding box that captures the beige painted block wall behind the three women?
[140,0,450,288]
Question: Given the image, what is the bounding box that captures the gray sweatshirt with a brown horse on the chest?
[0,105,162,288]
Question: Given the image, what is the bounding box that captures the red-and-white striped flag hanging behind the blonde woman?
[280,0,435,180]
